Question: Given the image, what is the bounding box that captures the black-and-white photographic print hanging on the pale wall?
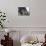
[18,7,30,16]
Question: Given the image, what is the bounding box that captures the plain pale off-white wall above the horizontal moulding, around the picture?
[0,0,46,27]
